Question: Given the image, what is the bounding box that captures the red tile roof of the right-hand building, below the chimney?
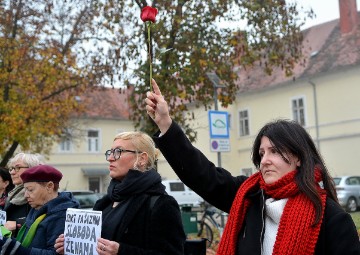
[238,13,360,93]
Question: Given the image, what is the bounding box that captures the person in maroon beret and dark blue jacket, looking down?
[0,165,80,255]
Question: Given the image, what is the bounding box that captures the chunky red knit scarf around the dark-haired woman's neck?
[217,170,326,255]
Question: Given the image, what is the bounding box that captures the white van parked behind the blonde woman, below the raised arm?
[162,180,204,207]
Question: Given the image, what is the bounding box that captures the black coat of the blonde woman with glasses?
[94,187,186,255]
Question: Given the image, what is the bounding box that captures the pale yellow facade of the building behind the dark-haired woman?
[159,66,360,178]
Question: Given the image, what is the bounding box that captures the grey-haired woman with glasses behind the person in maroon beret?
[4,152,44,236]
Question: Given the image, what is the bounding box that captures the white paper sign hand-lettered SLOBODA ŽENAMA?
[64,208,102,255]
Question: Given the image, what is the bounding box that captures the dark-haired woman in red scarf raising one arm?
[145,80,360,255]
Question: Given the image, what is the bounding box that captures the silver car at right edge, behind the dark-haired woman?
[333,176,360,212]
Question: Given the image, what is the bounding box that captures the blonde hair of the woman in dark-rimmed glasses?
[114,131,159,169]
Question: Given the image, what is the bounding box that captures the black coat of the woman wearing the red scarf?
[154,121,360,255]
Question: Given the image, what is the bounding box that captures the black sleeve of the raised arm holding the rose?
[153,121,247,212]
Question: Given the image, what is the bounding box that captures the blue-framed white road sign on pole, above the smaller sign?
[209,111,230,138]
